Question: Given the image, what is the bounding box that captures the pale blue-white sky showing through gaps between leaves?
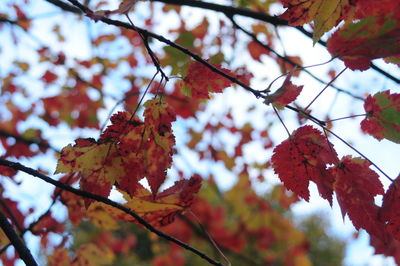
[0,1,400,266]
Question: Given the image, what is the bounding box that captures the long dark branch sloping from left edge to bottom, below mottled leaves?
[0,158,223,266]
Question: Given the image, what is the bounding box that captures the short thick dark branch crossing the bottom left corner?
[0,210,38,266]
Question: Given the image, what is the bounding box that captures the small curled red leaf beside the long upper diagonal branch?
[264,68,303,109]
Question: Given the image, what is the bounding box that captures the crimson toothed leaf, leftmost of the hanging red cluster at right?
[271,125,338,204]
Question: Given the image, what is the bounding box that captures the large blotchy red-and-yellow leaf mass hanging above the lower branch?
[55,99,176,205]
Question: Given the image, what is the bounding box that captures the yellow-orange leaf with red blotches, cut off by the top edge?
[280,0,355,43]
